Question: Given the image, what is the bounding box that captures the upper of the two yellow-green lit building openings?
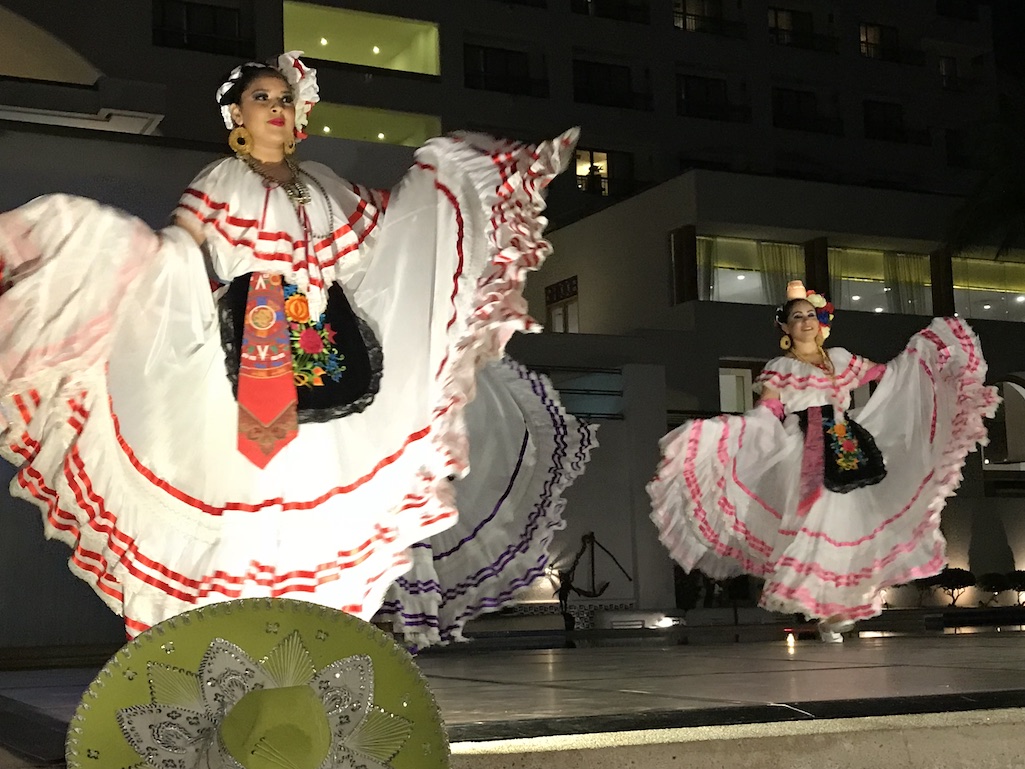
[282,0,441,75]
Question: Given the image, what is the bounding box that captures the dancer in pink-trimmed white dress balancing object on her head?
[648,281,999,642]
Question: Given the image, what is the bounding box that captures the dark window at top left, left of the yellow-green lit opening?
[153,0,256,57]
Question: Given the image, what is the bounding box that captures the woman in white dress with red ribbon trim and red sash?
[0,52,594,648]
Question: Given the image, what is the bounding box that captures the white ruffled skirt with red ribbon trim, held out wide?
[0,133,594,635]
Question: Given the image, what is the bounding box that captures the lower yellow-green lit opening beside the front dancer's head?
[306,102,442,147]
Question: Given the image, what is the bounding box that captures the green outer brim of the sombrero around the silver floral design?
[67,598,449,769]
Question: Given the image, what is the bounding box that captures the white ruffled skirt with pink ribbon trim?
[648,318,998,618]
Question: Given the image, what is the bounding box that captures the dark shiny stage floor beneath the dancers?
[0,632,1025,769]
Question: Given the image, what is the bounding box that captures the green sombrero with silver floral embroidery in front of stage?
[67,598,449,769]
